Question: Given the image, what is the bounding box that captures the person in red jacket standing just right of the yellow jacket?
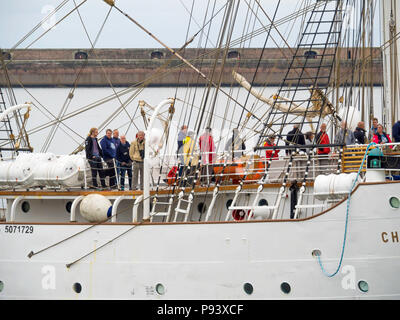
[199,127,215,185]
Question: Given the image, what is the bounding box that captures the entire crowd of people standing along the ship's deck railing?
[85,118,400,190]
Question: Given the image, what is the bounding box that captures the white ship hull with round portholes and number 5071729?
[0,182,400,299]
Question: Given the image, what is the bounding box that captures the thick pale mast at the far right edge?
[380,0,400,133]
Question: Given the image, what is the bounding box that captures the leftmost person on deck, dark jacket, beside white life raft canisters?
[85,128,106,188]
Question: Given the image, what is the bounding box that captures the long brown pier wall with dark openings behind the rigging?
[0,48,383,87]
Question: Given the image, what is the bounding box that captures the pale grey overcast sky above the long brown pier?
[0,0,379,49]
